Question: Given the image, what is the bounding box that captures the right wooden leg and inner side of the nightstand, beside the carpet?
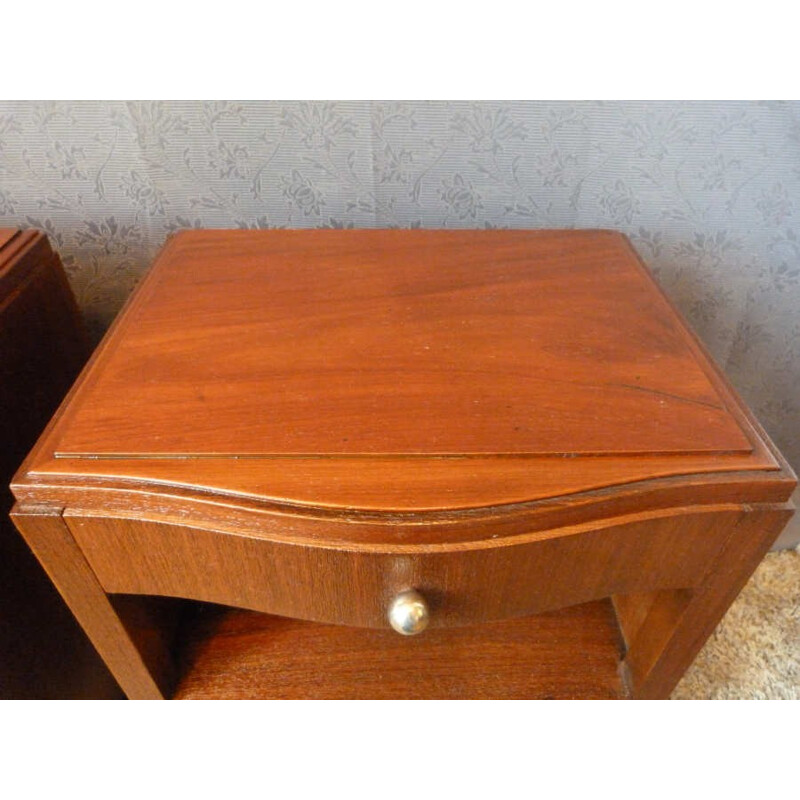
[614,504,792,699]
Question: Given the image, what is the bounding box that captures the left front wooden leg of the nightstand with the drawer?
[11,504,172,700]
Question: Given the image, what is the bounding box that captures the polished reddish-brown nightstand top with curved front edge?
[15,230,792,509]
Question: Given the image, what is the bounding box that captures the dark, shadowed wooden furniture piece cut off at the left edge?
[0,229,119,699]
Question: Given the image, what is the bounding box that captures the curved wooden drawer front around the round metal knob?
[64,506,743,628]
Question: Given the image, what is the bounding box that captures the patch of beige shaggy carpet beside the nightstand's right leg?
[672,550,800,700]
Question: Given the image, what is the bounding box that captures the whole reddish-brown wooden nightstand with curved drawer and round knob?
[13,231,795,698]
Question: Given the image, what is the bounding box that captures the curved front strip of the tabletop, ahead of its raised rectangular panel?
[31,448,780,511]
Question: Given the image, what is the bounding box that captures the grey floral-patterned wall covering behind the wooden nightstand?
[0,101,800,468]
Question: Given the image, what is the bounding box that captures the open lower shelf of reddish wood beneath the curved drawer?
[175,600,624,700]
